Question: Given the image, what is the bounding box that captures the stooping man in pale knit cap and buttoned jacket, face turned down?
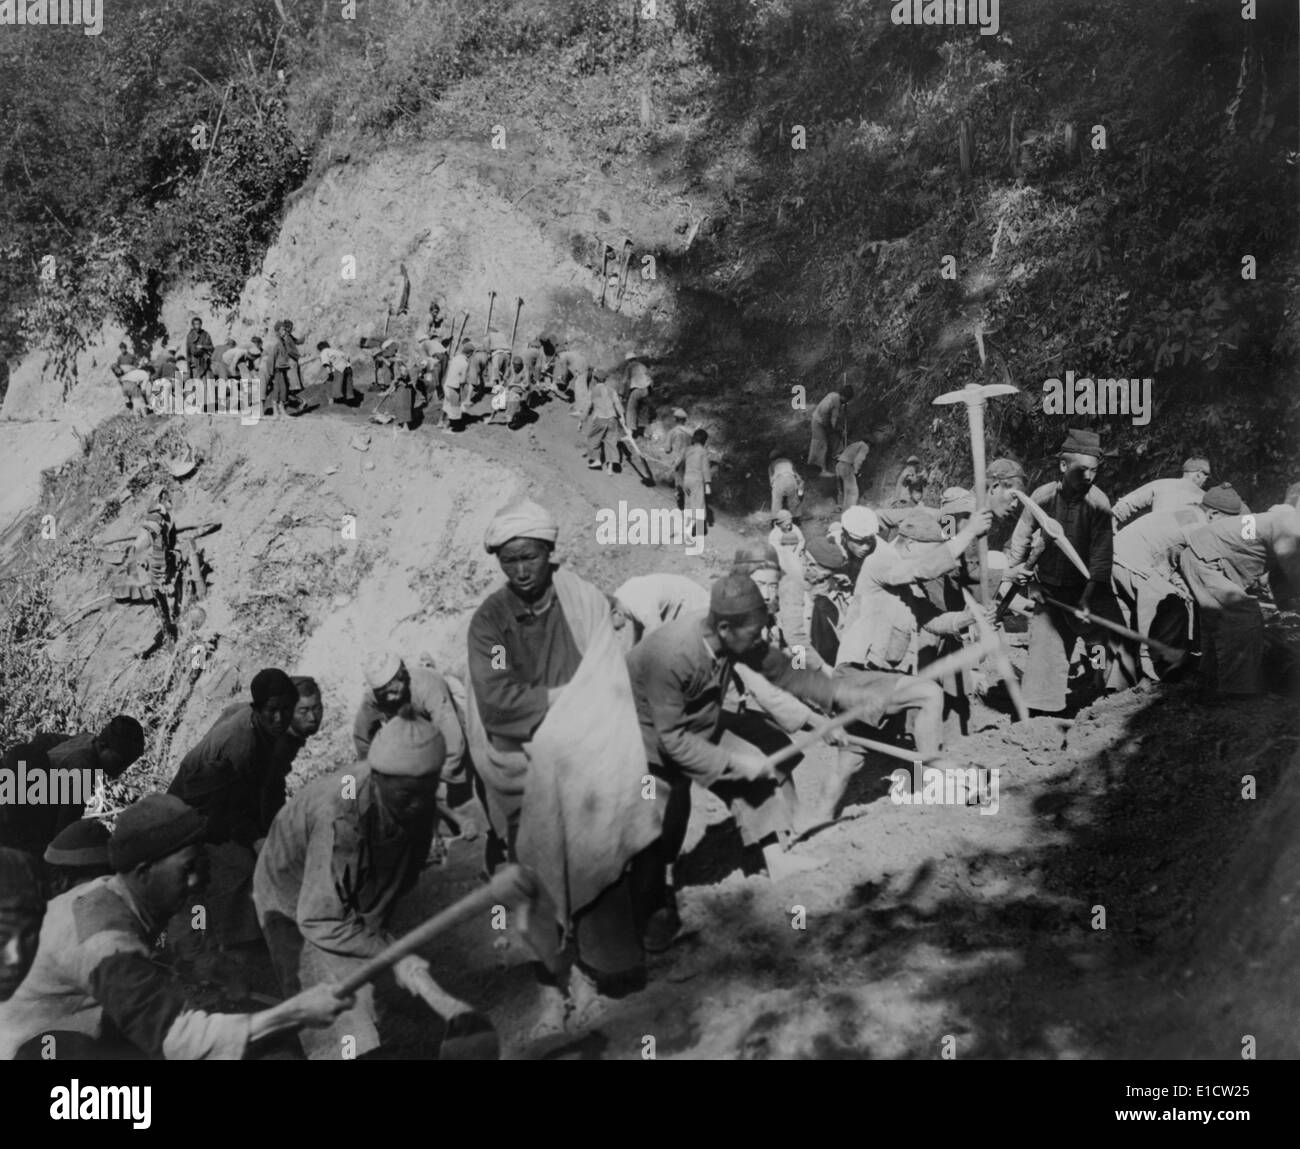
[254,710,468,1061]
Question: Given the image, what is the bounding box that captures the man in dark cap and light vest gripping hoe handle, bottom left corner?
[0,794,350,1061]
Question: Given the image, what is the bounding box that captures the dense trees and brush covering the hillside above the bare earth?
[0,0,1300,502]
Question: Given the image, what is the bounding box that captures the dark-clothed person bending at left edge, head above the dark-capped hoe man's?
[0,714,144,858]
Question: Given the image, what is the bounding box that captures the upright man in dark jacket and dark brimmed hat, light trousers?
[1006,430,1123,714]
